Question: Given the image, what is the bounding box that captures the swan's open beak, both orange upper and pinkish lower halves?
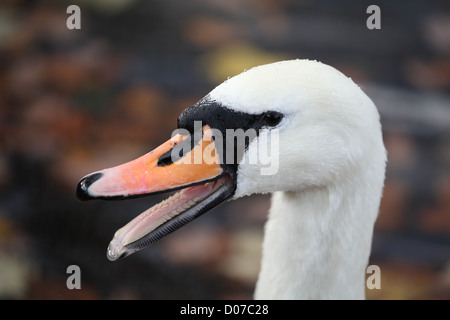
[77,125,235,261]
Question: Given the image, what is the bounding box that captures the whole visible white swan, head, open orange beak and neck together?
[77,60,386,299]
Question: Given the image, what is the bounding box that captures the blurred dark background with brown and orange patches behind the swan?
[0,0,450,299]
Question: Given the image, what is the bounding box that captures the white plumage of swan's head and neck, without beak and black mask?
[210,60,386,299]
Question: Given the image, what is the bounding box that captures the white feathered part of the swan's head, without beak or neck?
[207,60,385,198]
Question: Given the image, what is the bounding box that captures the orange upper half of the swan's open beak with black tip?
[77,125,223,200]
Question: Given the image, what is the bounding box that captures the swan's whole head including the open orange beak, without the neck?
[77,60,385,260]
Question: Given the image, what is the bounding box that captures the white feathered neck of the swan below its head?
[255,185,378,299]
